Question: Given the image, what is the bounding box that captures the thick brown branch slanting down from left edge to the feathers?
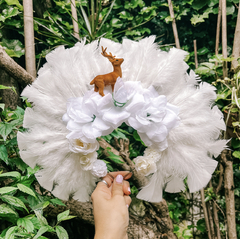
[0,46,34,85]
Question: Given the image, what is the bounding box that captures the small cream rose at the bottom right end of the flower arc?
[134,156,157,176]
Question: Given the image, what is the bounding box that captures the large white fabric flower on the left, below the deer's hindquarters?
[62,91,113,143]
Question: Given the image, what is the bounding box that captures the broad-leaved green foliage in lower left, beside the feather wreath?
[0,107,74,239]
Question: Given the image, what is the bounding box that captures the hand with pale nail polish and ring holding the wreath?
[91,172,131,239]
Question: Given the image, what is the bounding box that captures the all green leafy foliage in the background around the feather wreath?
[0,0,240,239]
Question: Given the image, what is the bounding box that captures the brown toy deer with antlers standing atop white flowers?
[90,47,124,96]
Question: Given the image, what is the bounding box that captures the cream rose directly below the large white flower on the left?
[68,139,99,155]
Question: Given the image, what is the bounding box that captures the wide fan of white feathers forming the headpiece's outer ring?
[18,36,226,202]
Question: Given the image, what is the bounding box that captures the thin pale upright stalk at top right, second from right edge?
[221,0,228,78]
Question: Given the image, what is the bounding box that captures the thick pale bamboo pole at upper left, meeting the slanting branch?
[23,0,36,77]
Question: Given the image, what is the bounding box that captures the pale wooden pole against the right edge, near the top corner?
[231,2,240,70]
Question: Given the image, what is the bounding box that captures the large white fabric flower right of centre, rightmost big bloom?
[128,87,180,151]
